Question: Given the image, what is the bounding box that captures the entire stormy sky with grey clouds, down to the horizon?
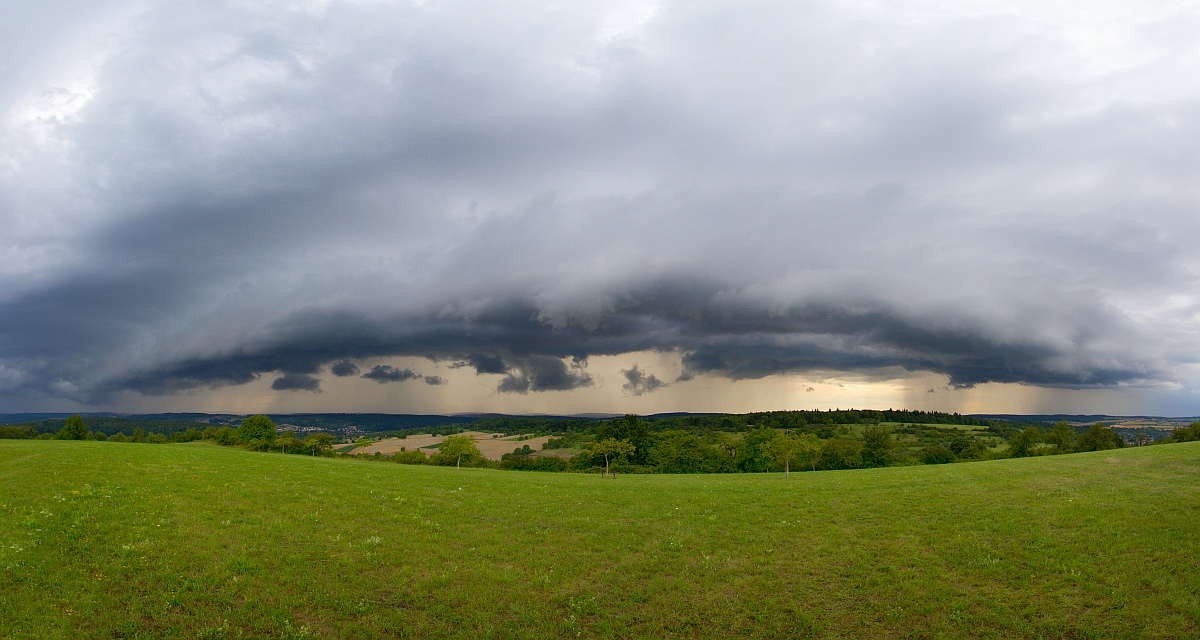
[0,0,1200,415]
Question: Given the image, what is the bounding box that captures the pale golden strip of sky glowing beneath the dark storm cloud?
[105,352,1161,415]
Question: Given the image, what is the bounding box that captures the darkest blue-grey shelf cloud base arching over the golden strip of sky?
[100,274,1153,395]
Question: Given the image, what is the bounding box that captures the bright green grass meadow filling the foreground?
[0,441,1200,638]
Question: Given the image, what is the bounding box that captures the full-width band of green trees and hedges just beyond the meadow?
[11,412,1200,475]
